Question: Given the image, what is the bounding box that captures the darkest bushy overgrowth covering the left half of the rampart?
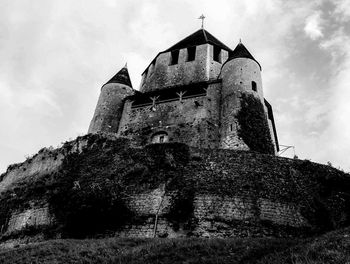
[0,135,189,237]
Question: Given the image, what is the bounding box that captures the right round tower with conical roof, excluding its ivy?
[220,42,264,150]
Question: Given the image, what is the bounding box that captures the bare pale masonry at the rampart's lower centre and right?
[104,190,309,237]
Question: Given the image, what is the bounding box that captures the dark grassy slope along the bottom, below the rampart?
[0,228,350,264]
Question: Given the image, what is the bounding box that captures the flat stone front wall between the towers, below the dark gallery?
[118,83,221,148]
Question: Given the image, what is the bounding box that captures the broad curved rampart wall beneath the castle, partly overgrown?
[0,135,350,244]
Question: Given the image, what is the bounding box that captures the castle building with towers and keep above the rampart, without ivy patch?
[89,28,278,152]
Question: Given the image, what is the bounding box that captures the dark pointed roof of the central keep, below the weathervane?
[163,29,231,52]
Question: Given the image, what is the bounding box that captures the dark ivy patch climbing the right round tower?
[237,93,275,154]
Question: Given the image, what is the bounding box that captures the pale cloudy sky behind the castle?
[0,0,350,172]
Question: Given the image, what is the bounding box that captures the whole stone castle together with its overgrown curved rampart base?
[0,26,350,245]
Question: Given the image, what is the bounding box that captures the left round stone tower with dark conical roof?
[88,65,134,133]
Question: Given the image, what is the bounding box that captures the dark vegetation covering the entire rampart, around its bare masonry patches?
[0,135,350,239]
